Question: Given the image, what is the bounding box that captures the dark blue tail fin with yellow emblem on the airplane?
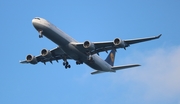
[105,49,116,66]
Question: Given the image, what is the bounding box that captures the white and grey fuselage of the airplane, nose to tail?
[32,18,114,72]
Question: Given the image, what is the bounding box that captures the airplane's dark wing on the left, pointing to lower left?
[20,47,71,64]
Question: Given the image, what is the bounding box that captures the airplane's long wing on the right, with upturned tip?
[72,34,162,54]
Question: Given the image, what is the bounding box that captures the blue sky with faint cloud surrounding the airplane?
[0,0,180,104]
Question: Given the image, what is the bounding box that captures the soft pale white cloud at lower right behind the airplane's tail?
[112,47,180,103]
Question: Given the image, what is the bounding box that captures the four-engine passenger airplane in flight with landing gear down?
[20,17,162,75]
